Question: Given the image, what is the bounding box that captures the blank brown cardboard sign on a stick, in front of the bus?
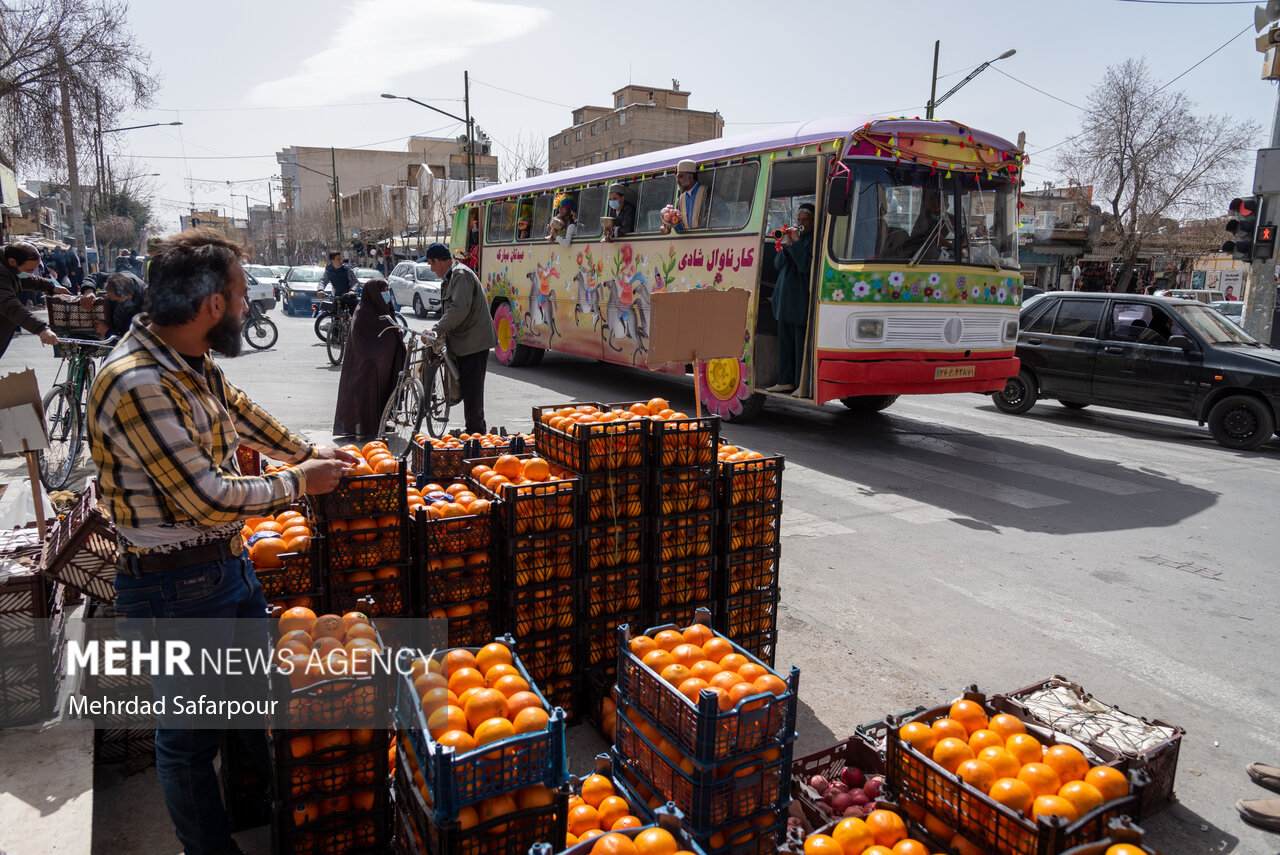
[645,288,751,365]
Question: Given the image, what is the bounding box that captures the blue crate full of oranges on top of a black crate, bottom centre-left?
[396,636,568,823]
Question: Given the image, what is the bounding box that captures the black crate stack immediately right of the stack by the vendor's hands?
[411,480,502,648]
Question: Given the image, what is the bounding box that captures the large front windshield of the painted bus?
[832,164,1018,264]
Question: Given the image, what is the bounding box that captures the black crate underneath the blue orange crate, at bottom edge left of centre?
[396,749,568,855]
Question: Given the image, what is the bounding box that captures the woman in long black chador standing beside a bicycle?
[333,279,406,443]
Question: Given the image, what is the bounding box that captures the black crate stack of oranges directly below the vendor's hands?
[314,471,412,617]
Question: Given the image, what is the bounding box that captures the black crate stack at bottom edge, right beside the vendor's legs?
[269,627,392,855]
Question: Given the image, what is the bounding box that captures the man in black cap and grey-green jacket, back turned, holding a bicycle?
[425,243,498,434]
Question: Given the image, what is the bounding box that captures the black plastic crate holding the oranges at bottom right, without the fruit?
[884,689,1149,855]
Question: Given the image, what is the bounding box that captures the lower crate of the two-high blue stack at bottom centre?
[612,695,792,836]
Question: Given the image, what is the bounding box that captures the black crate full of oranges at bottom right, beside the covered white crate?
[886,687,1149,855]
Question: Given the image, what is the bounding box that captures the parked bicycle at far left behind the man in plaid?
[40,335,116,490]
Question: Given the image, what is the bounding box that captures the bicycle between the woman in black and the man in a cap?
[381,323,453,459]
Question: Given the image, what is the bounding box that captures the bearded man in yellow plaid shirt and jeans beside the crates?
[87,229,355,855]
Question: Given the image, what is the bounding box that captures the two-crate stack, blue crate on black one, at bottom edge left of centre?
[394,636,568,855]
